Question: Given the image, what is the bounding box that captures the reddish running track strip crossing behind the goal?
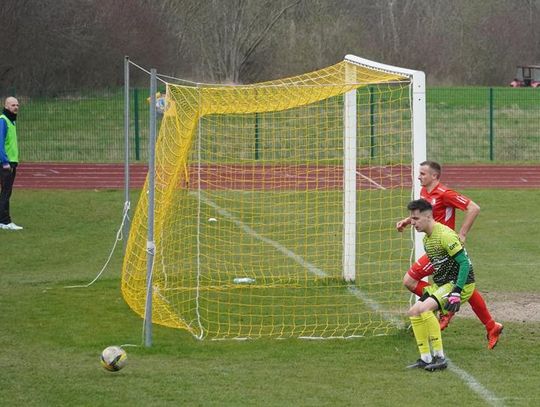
[15,163,540,190]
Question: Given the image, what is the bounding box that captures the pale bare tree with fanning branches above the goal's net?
[160,0,304,82]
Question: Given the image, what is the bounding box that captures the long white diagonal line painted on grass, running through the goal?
[190,192,504,407]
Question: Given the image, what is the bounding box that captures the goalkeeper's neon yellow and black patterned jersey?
[424,222,474,286]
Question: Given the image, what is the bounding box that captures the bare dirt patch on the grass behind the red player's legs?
[459,292,540,322]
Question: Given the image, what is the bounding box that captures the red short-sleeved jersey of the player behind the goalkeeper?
[420,182,471,230]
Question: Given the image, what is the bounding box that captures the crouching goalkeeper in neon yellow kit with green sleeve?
[407,199,475,371]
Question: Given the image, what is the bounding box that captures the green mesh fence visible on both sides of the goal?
[2,87,540,164]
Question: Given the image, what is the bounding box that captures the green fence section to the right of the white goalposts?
[427,88,540,163]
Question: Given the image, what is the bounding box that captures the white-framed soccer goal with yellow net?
[122,55,425,339]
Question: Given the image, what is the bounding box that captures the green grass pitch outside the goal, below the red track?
[0,190,540,406]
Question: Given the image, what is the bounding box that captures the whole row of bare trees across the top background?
[0,0,540,93]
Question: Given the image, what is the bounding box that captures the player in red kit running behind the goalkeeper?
[396,161,503,349]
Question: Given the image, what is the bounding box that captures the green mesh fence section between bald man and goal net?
[12,88,149,163]
